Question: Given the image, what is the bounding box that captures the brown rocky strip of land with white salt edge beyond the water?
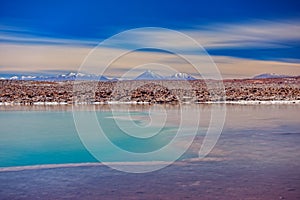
[0,77,300,105]
